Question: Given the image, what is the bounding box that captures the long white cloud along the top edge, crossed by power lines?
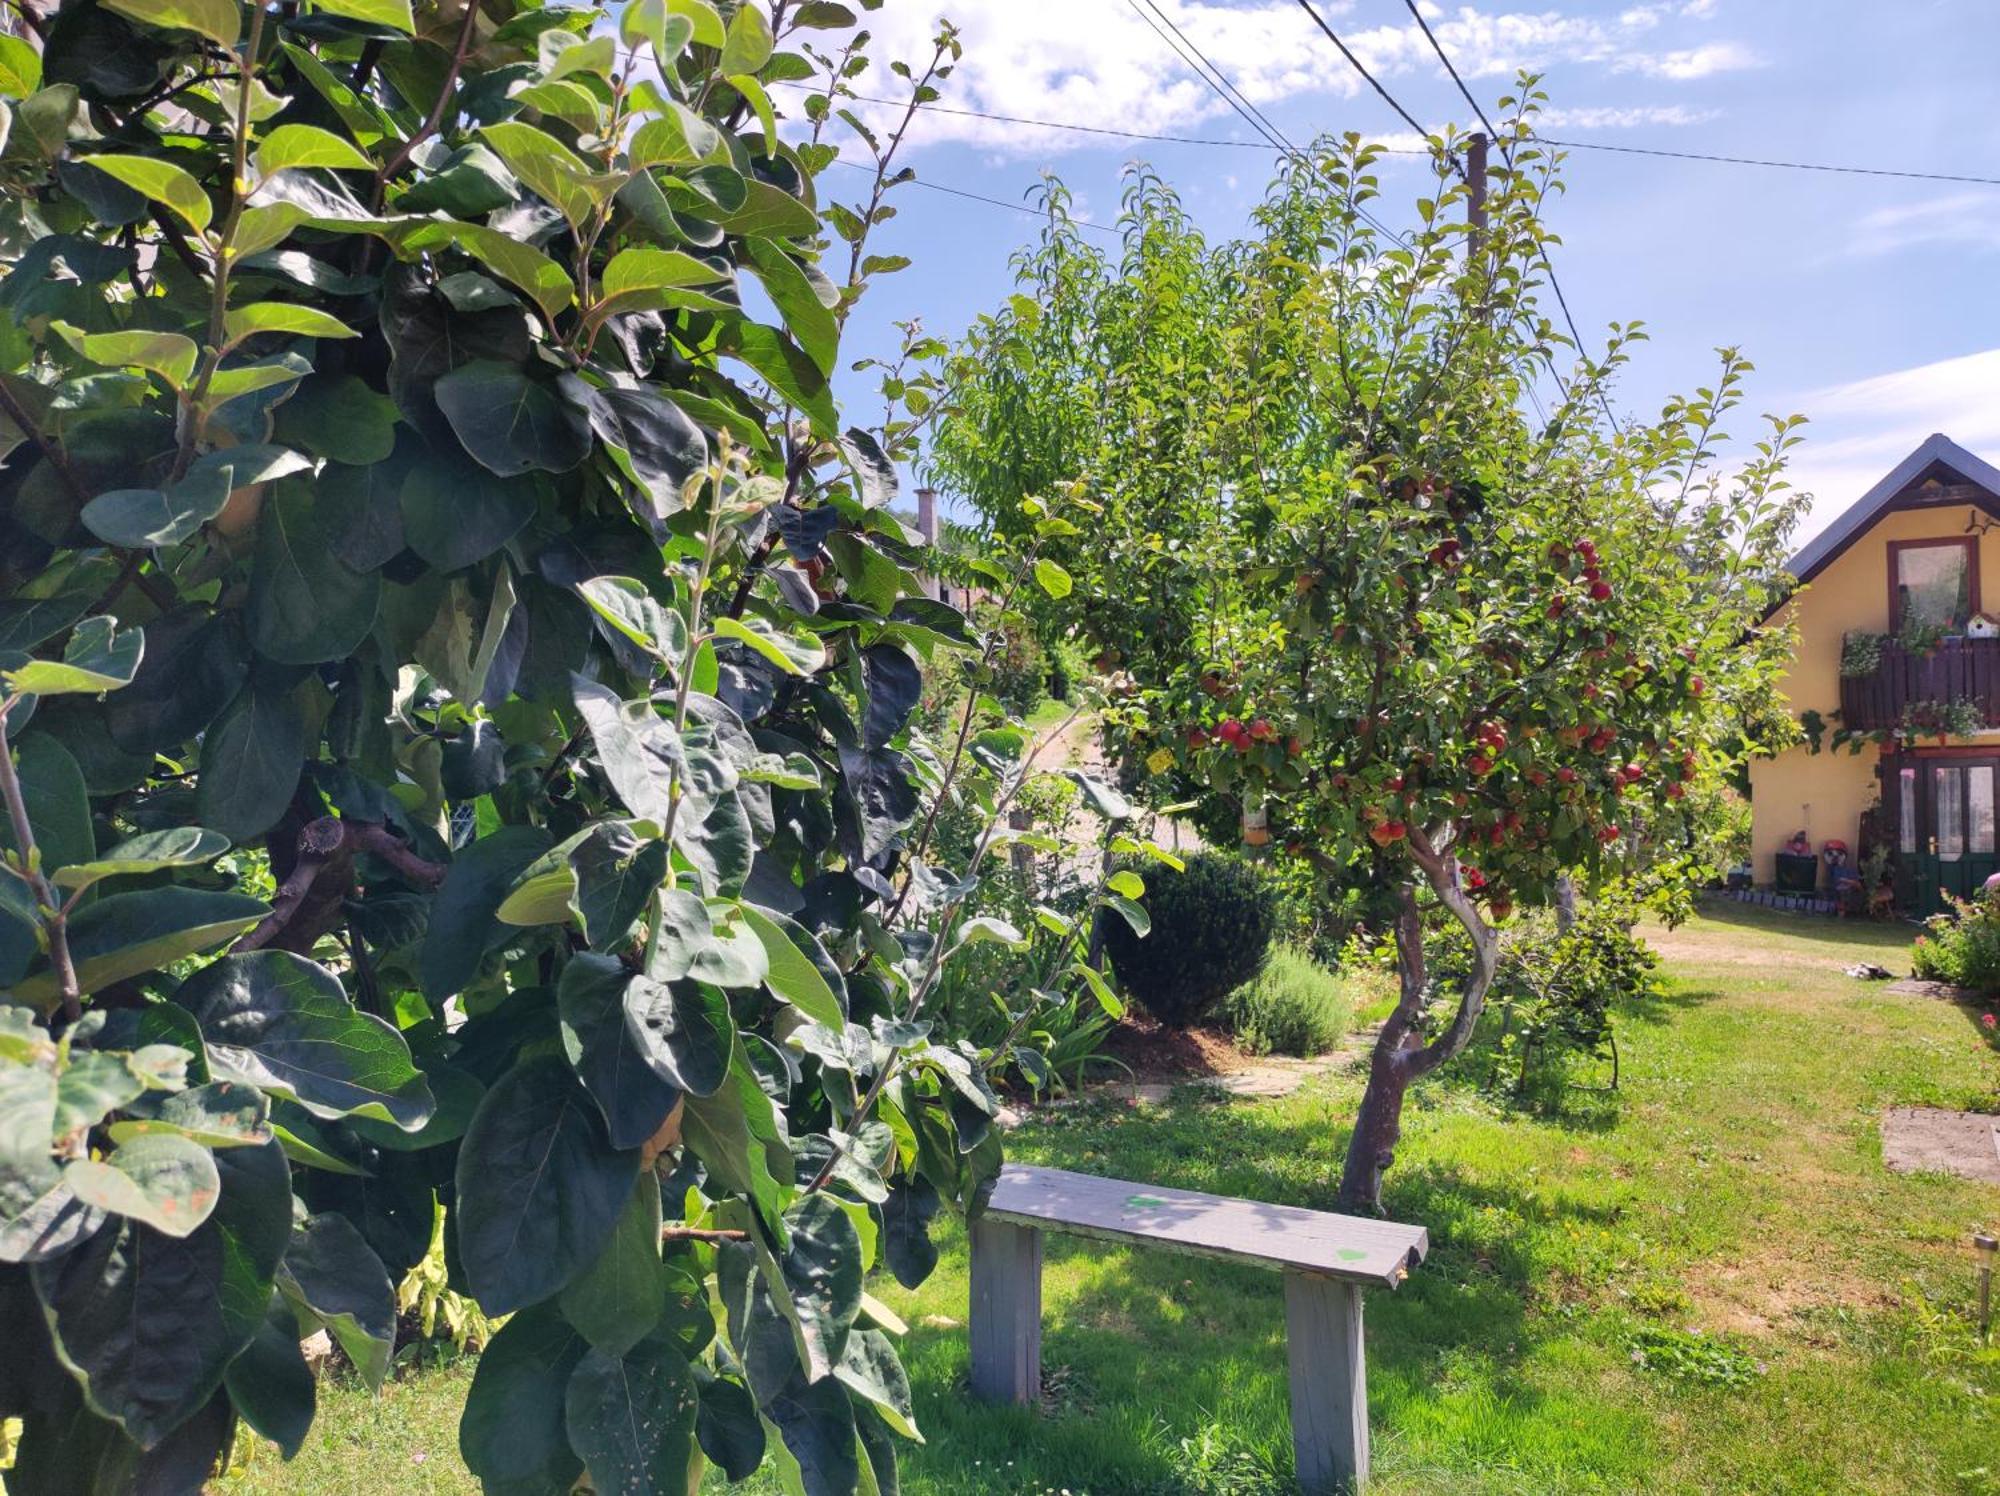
[856,0,1754,158]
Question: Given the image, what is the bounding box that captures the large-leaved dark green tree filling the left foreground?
[0,0,1152,1496]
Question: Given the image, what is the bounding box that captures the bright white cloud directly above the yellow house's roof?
[1792,348,2000,540]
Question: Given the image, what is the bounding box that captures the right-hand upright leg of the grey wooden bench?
[1284,1272,1368,1496]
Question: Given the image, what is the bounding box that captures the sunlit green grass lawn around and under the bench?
[226,906,2000,1496]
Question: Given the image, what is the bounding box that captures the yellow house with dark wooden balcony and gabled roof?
[1750,426,2000,914]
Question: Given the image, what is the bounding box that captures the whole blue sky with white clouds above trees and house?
[808,0,2000,538]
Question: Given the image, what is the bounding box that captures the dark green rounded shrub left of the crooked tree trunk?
[1102,852,1278,1028]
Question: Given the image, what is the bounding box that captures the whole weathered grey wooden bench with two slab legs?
[972,1164,1430,1496]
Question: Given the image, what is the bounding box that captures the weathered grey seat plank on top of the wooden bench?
[986,1164,1430,1288]
